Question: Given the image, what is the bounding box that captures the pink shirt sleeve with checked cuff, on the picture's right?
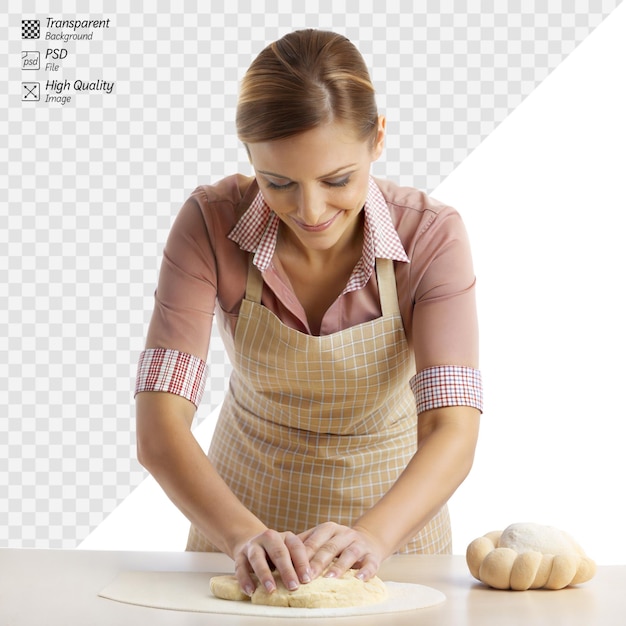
[410,207,483,413]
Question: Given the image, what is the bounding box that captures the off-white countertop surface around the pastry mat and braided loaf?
[0,549,626,626]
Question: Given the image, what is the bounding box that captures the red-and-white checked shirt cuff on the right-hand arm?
[410,365,483,414]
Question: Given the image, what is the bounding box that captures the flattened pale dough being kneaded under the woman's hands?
[210,570,387,609]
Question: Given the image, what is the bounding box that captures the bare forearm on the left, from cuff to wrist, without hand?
[137,393,266,557]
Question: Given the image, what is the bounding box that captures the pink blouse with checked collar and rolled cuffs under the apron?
[135,175,482,413]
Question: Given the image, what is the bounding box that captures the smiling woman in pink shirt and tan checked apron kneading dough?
[136,30,482,594]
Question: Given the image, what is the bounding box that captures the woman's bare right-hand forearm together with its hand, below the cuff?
[300,406,480,580]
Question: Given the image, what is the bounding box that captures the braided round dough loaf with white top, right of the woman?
[466,523,596,591]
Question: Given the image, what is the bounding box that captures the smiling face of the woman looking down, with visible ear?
[248,116,385,251]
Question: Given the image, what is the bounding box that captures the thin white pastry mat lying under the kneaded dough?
[98,572,446,617]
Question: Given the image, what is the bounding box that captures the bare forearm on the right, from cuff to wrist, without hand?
[354,407,479,556]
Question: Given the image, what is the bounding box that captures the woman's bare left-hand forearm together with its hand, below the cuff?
[136,392,309,593]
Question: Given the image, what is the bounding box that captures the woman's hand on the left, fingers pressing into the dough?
[233,529,311,596]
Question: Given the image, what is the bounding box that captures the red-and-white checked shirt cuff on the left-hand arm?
[135,348,207,407]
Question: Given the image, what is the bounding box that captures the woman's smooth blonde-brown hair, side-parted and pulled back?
[236,29,378,144]
